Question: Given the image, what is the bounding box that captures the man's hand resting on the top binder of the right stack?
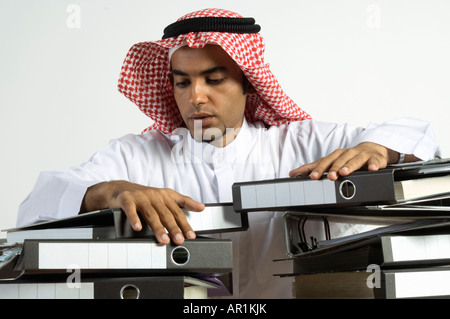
[289,142,399,181]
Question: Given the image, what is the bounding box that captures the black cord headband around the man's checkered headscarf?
[162,17,261,40]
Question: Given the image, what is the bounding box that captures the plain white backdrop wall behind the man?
[0,0,450,237]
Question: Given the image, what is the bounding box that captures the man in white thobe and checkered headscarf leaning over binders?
[18,9,438,298]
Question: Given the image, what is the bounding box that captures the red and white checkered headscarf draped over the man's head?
[118,9,310,133]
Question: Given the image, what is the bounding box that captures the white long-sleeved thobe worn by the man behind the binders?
[17,119,439,298]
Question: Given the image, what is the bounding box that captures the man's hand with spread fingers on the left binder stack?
[81,181,205,245]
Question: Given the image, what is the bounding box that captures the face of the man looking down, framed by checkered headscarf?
[171,45,247,146]
